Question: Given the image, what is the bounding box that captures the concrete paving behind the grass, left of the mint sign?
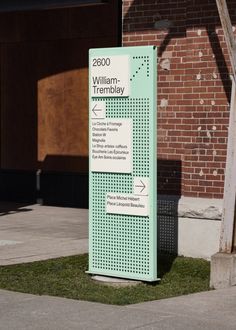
[0,202,88,265]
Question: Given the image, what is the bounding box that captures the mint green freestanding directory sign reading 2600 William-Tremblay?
[89,46,157,281]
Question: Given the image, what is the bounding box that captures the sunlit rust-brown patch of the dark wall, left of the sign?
[38,68,88,166]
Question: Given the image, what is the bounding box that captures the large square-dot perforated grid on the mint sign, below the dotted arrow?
[92,98,149,274]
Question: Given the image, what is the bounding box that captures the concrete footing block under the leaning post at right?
[210,253,236,289]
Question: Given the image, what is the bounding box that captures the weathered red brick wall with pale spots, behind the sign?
[123,0,236,198]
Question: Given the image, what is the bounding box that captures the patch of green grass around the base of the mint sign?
[0,254,210,305]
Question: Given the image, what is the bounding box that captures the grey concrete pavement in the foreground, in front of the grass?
[0,287,236,330]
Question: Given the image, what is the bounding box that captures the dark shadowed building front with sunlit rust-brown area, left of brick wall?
[0,0,121,208]
